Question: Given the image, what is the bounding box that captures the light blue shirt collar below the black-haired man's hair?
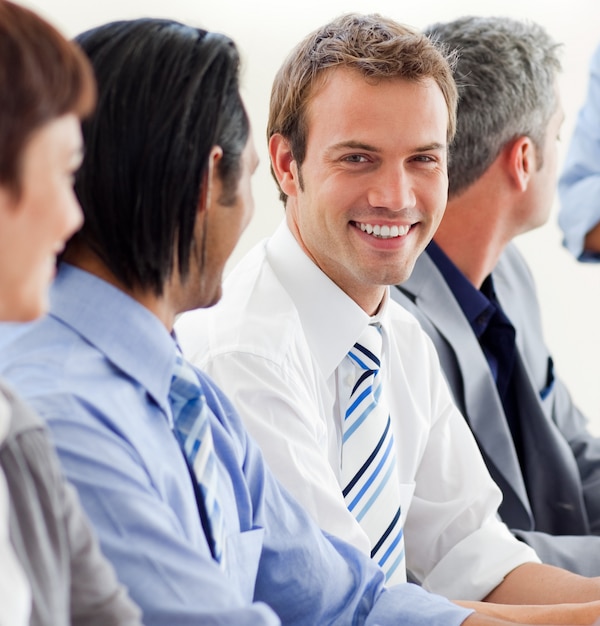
[50,263,176,416]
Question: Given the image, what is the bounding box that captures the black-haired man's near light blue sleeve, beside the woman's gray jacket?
[37,394,280,626]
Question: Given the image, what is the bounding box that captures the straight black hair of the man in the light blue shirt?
[75,19,249,295]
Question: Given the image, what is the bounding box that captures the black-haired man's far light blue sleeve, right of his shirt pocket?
[200,376,470,626]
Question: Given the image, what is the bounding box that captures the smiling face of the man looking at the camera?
[271,68,448,313]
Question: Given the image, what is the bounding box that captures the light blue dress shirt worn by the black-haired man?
[1,265,470,626]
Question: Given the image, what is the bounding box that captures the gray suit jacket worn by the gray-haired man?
[392,244,600,576]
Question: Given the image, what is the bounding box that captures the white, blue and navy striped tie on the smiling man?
[342,325,406,584]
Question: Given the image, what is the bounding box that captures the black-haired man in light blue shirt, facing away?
[2,13,599,626]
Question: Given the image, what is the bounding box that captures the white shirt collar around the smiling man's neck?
[266,220,389,378]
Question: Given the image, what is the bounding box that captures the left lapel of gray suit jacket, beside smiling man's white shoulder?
[401,252,531,526]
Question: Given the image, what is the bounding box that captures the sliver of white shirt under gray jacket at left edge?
[0,393,31,626]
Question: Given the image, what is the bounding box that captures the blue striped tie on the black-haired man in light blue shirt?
[169,354,224,565]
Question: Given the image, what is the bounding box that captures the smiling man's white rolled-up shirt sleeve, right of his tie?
[394,321,539,600]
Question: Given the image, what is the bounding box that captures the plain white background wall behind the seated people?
[22,0,600,434]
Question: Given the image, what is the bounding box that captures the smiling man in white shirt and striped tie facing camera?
[178,15,600,612]
